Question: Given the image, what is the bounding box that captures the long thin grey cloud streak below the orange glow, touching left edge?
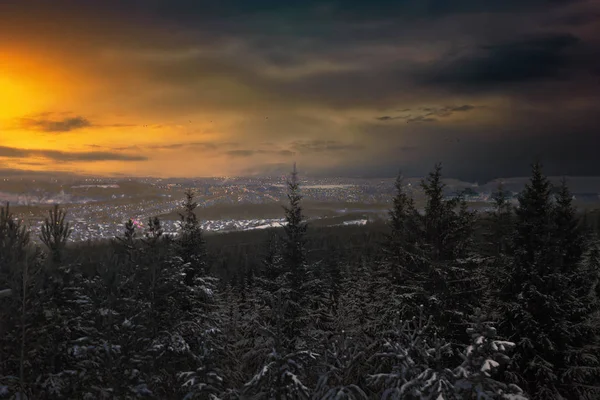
[0,146,148,162]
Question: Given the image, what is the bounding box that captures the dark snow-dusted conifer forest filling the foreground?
[0,163,600,400]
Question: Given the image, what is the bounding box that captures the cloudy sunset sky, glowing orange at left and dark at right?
[0,0,600,182]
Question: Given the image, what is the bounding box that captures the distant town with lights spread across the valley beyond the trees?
[0,173,600,241]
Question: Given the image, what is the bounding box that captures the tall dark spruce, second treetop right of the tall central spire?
[401,164,481,343]
